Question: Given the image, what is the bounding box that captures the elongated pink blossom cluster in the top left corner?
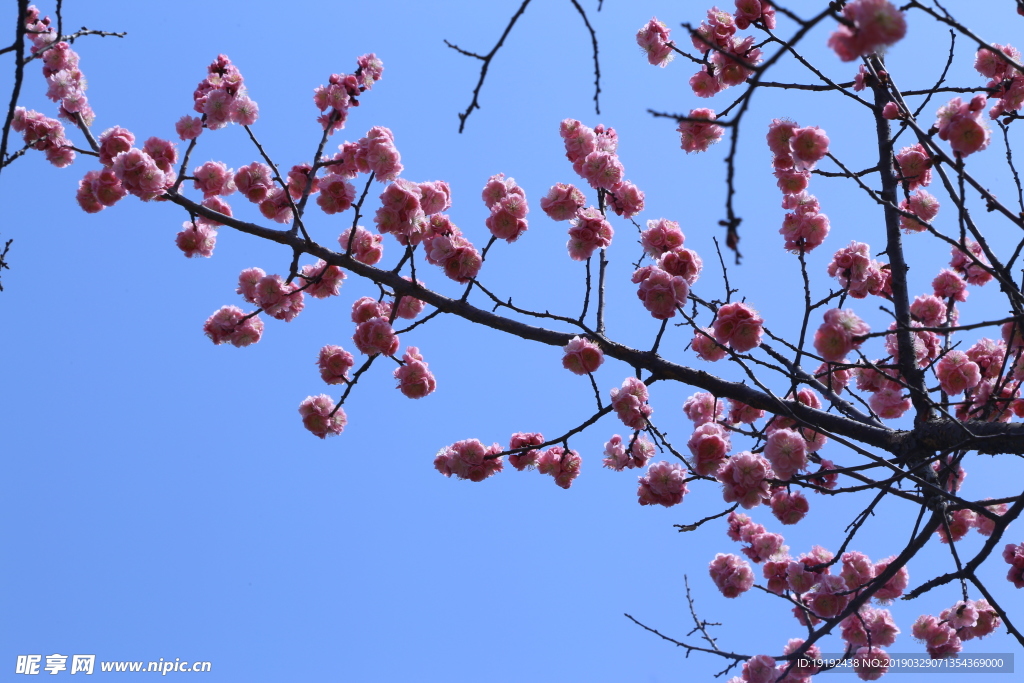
[26,5,96,126]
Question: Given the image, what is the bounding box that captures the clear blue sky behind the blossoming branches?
[0,0,1024,681]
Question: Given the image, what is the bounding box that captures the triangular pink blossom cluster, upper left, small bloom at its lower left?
[189,54,259,133]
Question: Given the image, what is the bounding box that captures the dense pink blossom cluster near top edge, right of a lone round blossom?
[690,3,761,97]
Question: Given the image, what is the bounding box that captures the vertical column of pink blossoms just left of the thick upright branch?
[767,119,829,253]
